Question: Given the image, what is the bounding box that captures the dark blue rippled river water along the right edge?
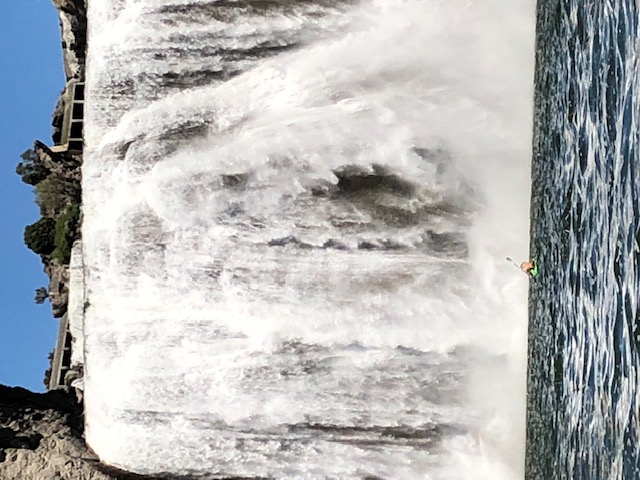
[526,1,640,479]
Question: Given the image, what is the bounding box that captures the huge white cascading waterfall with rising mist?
[83,0,534,480]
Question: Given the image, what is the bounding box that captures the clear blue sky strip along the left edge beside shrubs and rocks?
[0,0,65,391]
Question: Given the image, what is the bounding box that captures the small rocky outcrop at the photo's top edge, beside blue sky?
[53,0,87,80]
